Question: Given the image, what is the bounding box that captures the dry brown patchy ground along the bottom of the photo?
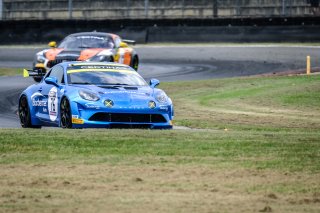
[0,164,320,212]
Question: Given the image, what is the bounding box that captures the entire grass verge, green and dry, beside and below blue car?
[0,75,320,212]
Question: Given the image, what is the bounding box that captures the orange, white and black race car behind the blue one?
[33,32,139,82]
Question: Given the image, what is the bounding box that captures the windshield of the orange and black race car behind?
[58,36,114,49]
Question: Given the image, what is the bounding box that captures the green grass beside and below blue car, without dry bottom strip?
[0,75,320,171]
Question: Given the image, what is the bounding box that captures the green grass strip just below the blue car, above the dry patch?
[0,129,320,172]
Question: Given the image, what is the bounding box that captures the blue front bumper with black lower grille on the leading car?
[71,99,173,129]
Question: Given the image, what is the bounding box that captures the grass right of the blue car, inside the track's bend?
[162,75,320,131]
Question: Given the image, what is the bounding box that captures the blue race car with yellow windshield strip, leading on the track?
[19,61,174,129]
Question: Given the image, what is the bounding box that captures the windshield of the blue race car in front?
[68,71,147,86]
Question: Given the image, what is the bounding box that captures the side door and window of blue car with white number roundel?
[37,65,64,126]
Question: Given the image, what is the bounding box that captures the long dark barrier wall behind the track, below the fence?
[0,17,320,44]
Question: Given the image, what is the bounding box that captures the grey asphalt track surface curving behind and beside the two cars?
[0,45,320,128]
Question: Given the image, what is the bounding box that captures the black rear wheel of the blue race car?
[18,95,41,128]
